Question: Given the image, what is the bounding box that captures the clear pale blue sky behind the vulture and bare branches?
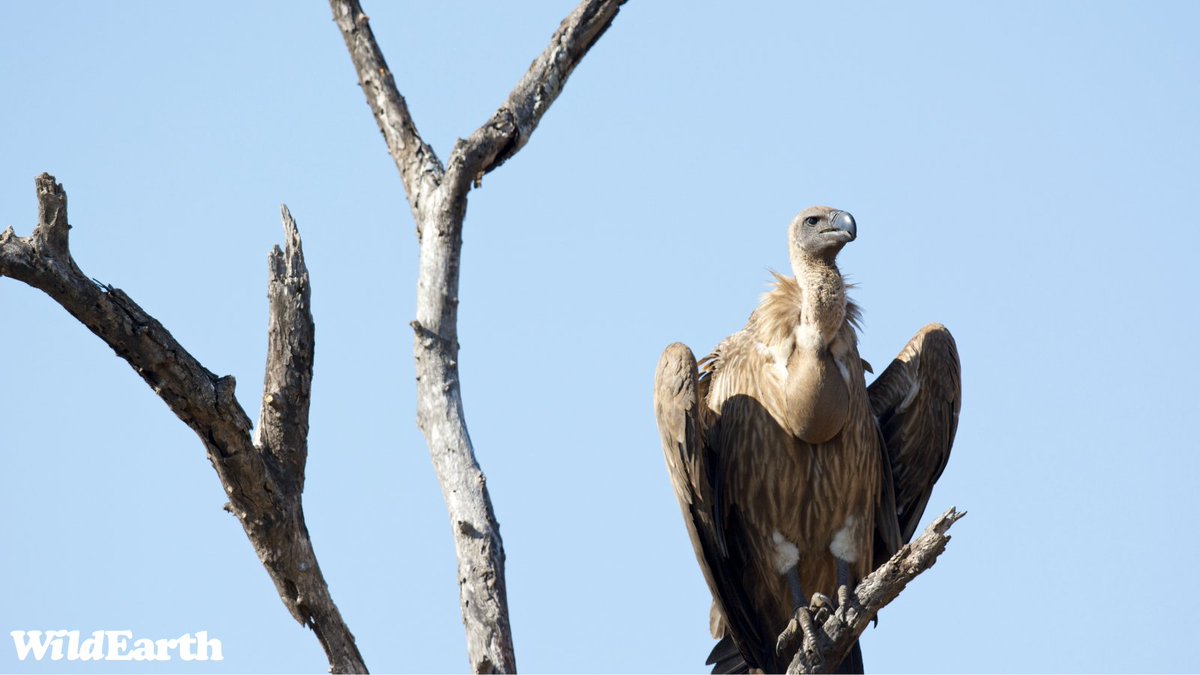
[0,0,1200,673]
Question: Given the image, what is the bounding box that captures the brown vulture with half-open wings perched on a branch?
[654,207,961,673]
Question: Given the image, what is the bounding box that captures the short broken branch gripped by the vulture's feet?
[779,508,966,674]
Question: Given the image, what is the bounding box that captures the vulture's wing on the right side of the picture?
[866,323,962,540]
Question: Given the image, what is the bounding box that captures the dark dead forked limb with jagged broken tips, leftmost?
[0,173,366,673]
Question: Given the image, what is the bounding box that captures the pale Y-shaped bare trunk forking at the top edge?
[330,0,624,673]
